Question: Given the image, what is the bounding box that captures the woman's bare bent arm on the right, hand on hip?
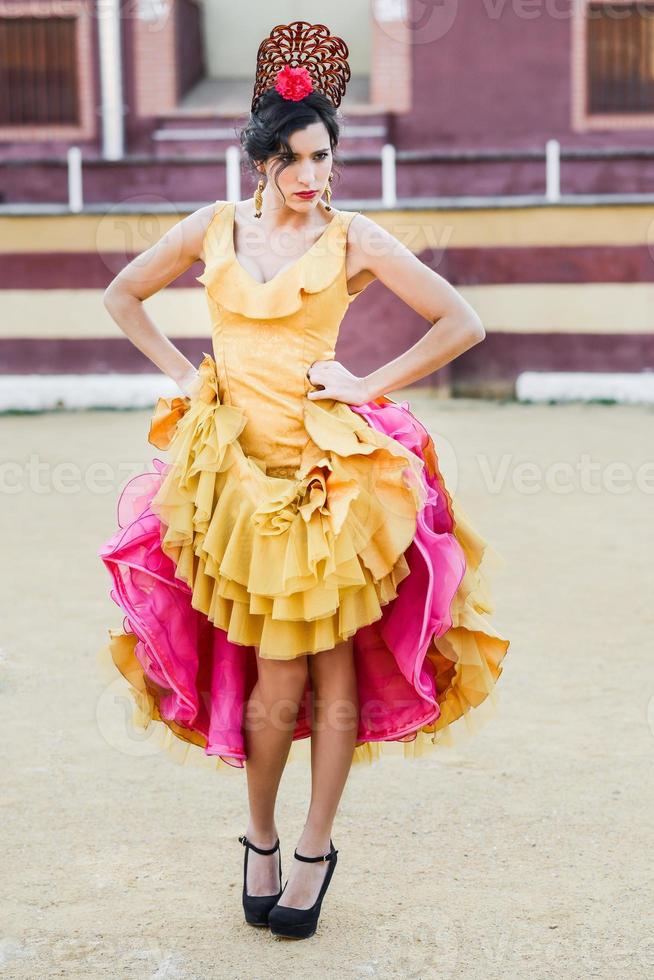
[307,214,486,405]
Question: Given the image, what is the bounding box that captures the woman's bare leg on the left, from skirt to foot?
[244,648,308,895]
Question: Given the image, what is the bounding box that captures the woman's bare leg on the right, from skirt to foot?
[280,638,359,908]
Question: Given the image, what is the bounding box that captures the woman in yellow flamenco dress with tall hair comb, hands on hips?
[99,22,509,938]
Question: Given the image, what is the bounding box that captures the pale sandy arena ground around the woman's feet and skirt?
[0,393,654,980]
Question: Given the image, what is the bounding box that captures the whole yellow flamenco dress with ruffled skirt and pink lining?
[99,201,509,768]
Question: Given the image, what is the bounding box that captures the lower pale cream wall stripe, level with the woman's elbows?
[0,283,654,338]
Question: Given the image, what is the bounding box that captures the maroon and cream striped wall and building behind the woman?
[0,0,654,395]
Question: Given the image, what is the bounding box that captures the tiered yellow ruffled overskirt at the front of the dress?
[149,353,425,660]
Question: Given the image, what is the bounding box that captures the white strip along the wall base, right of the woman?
[515,371,654,404]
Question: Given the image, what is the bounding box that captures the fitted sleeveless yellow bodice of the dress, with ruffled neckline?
[197,201,362,474]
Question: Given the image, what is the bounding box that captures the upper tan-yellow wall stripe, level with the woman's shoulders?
[0,204,654,253]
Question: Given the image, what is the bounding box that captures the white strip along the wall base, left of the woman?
[0,373,182,412]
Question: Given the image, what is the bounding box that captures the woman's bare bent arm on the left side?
[103,204,214,395]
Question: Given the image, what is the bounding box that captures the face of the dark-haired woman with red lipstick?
[265,122,332,211]
